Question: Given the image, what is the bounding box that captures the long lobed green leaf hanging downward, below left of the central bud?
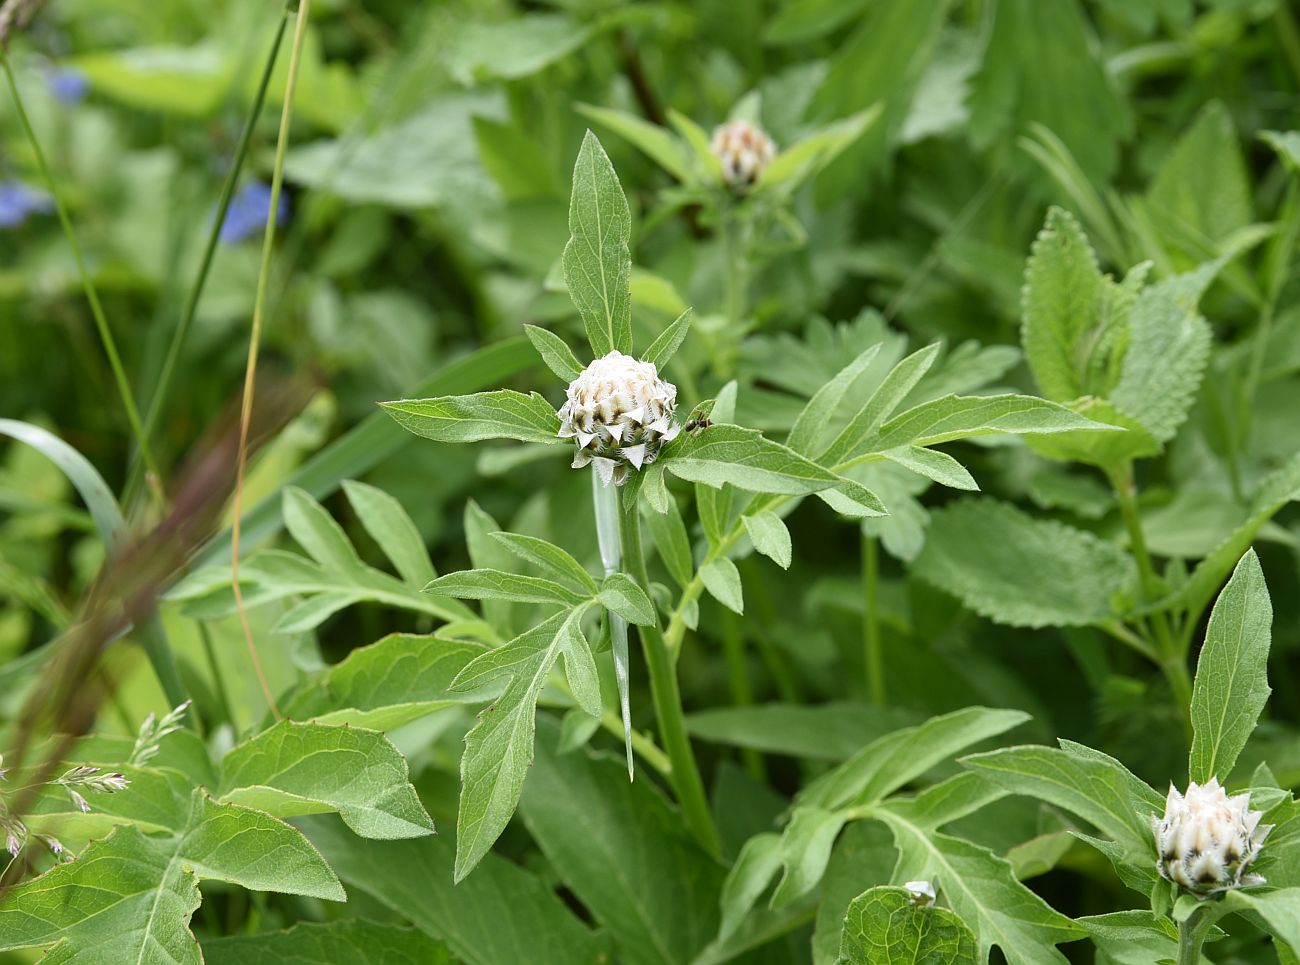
[454,607,585,882]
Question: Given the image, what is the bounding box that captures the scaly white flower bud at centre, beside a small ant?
[559,351,679,486]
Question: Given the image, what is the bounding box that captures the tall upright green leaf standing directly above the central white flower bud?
[563,131,632,358]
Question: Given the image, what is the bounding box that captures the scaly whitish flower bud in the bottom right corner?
[1151,778,1273,895]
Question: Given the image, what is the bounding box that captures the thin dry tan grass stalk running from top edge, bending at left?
[230,0,312,719]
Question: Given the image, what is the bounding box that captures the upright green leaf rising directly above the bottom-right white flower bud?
[1187,550,1273,783]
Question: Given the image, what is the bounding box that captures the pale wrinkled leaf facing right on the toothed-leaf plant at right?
[1110,260,1223,442]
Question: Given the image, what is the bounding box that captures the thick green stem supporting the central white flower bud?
[621,494,722,854]
